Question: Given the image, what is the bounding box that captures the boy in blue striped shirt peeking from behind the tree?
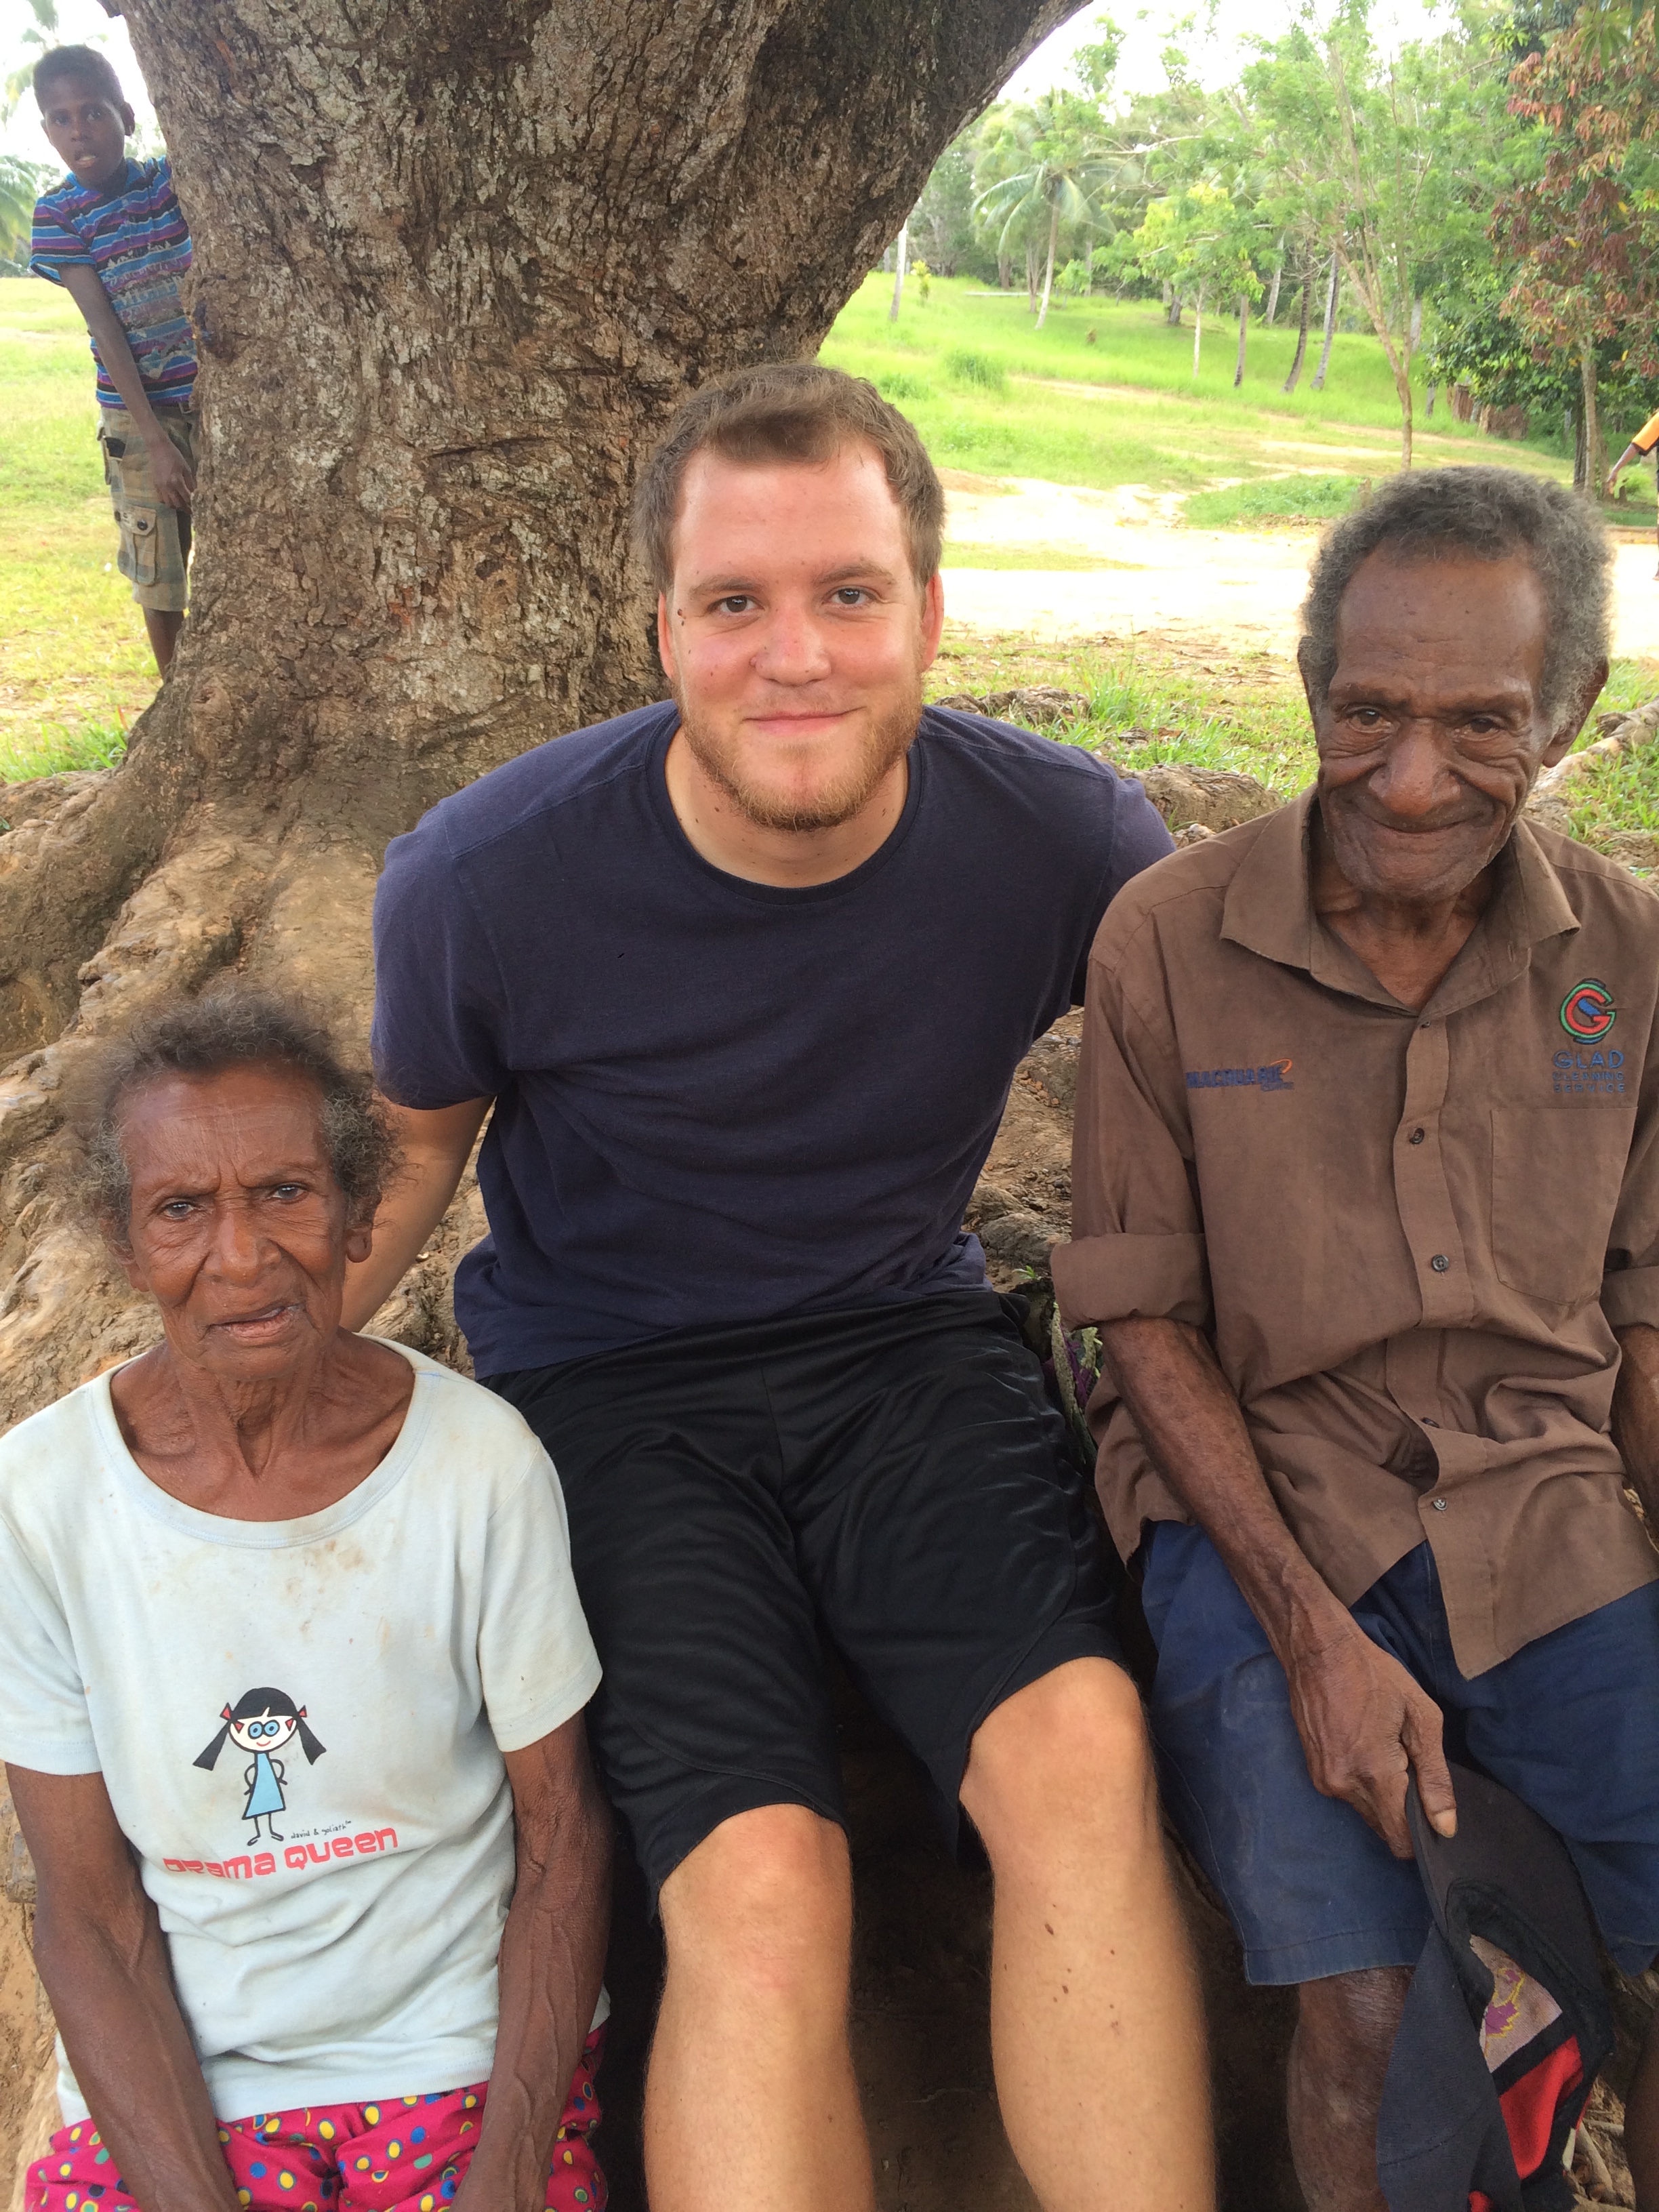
[28,47,197,675]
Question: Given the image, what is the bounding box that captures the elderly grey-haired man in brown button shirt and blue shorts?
[1055,469,1659,2212]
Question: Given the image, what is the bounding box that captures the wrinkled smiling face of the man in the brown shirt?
[1309,548,1599,905]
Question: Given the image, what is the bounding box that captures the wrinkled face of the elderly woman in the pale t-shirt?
[119,1066,369,1382]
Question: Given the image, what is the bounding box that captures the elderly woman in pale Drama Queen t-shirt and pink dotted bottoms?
[0,996,611,2212]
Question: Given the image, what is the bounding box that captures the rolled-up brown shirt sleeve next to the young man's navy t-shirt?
[1053,922,1212,1330]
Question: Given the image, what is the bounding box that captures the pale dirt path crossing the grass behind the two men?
[945,469,1659,659]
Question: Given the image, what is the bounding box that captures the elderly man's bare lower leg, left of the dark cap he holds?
[1290,1967,1411,2212]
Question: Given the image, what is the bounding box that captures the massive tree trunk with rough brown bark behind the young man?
[0,0,1075,1427]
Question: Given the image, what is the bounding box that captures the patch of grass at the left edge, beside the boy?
[0,276,155,783]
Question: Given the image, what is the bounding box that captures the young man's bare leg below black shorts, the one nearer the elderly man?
[962,1659,1214,2212]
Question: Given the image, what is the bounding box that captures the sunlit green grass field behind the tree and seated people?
[0,276,1659,830]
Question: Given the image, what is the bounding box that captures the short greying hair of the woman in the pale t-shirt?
[68,991,398,1243]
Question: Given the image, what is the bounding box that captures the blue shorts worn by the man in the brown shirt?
[1141,1522,1659,1982]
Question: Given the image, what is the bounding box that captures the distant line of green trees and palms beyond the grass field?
[909,0,1659,483]
